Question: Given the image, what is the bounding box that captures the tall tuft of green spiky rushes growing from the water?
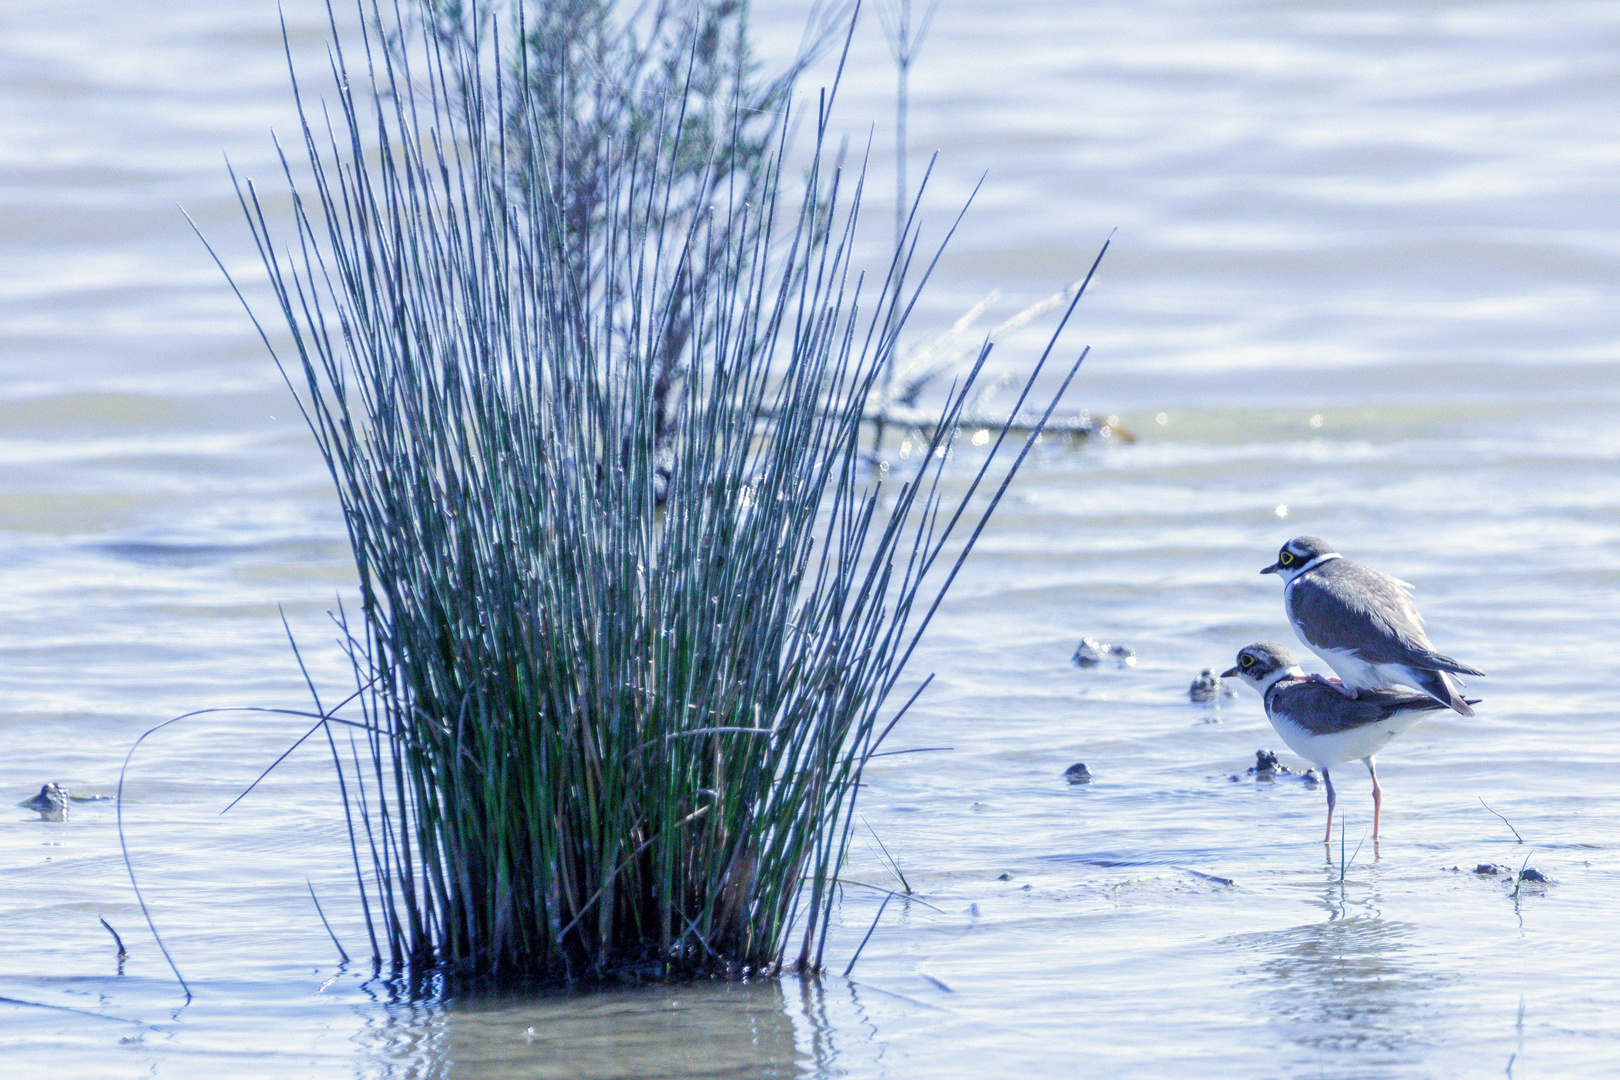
[218,5,1079,981]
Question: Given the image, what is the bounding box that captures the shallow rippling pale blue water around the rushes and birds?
[0,2,1620,1078]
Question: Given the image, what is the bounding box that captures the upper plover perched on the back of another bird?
[1260,536,1484,716]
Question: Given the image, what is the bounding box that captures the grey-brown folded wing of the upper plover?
[1288,559,1439,664]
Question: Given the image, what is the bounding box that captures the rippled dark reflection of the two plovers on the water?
[1230,882,1445,1051]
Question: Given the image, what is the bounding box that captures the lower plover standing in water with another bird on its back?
[1221,641,1473,844]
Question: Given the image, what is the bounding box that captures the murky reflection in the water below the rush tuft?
[358,981,804,1080]
